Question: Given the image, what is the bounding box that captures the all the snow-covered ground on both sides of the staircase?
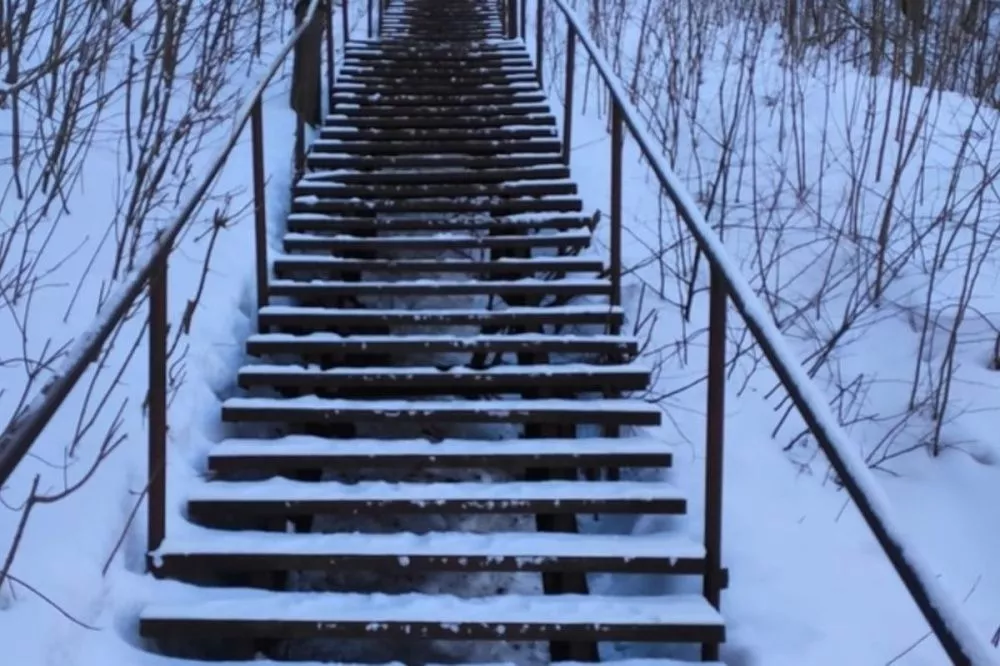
[0,2,1000,666]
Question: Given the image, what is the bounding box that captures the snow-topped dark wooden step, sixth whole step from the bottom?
[237,363,652,397]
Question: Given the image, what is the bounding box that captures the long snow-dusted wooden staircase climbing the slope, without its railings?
[140,0,724,663]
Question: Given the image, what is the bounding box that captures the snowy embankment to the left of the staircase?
[0,0,363,666]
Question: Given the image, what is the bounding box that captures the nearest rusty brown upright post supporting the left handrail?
[146,246,169,573]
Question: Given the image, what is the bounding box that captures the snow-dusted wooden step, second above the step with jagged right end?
[292,179,577,200]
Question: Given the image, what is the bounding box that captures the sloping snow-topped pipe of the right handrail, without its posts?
[532,0,998,666]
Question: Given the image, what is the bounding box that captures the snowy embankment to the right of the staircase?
[529,2,1000,666]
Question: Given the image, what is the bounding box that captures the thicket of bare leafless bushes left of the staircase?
[0,0,284,594]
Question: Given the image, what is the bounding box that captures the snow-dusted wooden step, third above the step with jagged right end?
[297,165,576,188]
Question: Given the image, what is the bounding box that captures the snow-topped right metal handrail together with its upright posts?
[528,0,998,666]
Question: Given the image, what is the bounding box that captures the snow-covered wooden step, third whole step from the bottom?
[187,477,687,521]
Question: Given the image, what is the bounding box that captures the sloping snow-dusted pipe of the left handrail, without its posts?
[0,0,328,486]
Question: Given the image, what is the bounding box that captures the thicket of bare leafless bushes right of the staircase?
[548,0,1000,465]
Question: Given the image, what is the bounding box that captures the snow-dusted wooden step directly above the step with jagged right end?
[292,196,583,217]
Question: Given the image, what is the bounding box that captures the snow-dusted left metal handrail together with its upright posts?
[0,0,334,551]
